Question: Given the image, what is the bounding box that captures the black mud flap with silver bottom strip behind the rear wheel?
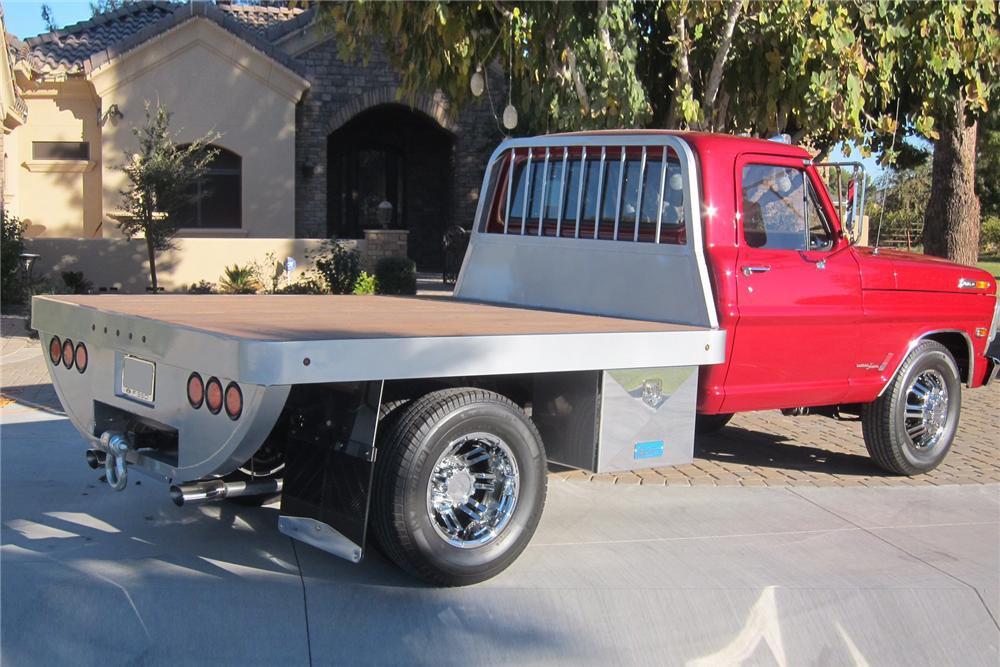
[278,380,382,563]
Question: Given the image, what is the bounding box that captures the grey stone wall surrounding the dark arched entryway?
[295,39,506,266]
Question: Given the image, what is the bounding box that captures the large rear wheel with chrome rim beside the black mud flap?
[372,388,546,586]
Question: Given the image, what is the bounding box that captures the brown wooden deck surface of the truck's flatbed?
[39,295,698,341]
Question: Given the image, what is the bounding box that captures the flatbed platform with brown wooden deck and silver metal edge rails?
[33,295,725,386]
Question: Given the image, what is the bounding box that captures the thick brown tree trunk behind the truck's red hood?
[923,99,979,264]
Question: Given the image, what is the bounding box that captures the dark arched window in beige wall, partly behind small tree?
[180,146,243,229]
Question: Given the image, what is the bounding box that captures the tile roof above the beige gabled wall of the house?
[22,1,307,74]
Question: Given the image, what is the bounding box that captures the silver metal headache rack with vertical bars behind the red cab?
[455,132,718,329]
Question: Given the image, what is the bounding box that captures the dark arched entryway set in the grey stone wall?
[327,104,453,270]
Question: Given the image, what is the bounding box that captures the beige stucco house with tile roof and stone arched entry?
[2,2,503,291]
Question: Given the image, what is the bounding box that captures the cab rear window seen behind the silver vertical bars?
[483,146,685,244]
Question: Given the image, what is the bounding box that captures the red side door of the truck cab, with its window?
[723,155,862,412]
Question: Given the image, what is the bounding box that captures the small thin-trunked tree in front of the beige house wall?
[119,102,219,293]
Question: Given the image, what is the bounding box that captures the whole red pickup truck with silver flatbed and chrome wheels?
[33,131,1000,585]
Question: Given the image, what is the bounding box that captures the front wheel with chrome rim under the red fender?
[861,340,962,475]
